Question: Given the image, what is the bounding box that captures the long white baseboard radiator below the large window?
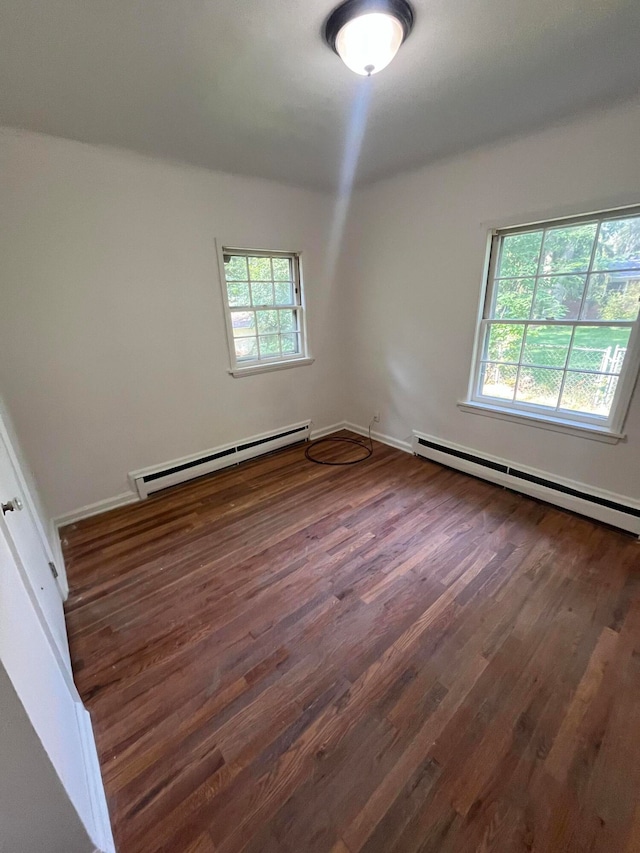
[413,431,640,536]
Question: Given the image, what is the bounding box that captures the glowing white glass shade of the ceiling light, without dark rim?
[336,12,404,77]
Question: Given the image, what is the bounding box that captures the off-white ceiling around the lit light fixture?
[0,0,640,187]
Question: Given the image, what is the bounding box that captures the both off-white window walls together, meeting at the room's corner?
[0,97,640,516]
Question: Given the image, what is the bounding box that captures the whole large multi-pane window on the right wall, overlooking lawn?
[470,204,640,432]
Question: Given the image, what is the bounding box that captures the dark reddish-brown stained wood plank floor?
[63,432,640,853]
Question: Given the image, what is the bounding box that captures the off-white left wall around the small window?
[0,130,343,516]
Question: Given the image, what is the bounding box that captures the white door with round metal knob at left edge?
[0,433,69,664]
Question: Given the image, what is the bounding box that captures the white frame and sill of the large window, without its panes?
[458,206,640,443]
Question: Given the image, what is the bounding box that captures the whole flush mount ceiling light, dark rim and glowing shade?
[324,0,413,77]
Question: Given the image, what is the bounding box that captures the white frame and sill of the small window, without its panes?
[216,243,314,377]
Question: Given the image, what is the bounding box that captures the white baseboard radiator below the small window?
[129,420,311,499]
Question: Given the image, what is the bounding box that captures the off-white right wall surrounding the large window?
[342,98,640,499]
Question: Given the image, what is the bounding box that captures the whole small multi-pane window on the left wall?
[222,248,310,374]
